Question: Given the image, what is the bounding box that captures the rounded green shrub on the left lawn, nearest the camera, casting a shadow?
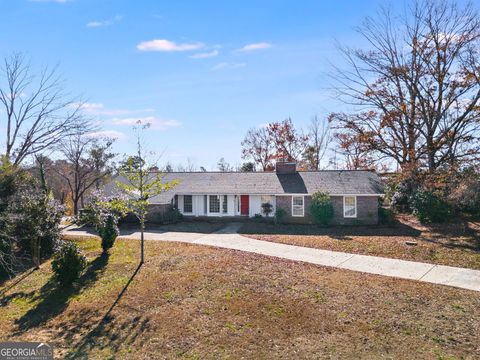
[52,242,87,286]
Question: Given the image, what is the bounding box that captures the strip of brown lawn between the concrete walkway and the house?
[239,216,480,269]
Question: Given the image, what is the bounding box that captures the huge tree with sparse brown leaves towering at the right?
[331,0,480,172]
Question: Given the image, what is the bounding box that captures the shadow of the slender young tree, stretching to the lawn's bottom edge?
[65,265,149,359]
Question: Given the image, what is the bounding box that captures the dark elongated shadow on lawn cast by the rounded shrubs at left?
[11,254,109,335]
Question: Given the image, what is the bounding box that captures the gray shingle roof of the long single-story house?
[107,170,384,203]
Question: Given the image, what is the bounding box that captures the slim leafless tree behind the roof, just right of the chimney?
[303,115,332,170]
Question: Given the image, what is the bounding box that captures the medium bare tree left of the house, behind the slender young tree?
[54,132,115,215]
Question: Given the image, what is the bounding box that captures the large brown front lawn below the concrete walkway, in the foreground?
[0,238,480,359]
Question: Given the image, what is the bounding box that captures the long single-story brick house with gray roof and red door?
[111,162,383,225]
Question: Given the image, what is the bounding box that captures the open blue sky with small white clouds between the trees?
[0,0,390,169]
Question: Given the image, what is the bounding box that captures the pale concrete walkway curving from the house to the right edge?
[64,223,480,291]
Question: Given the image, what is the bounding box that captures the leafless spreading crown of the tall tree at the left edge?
[0,54,86,165]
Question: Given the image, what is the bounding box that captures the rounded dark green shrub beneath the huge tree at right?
[410,188,453,223]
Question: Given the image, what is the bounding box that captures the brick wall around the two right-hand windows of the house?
[276,196,378,225]
